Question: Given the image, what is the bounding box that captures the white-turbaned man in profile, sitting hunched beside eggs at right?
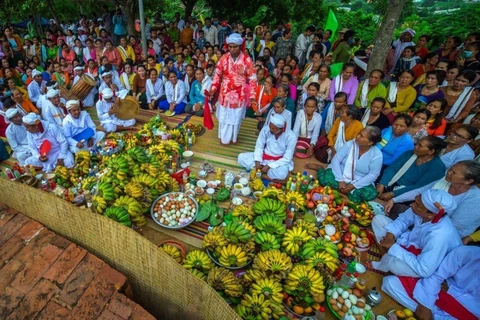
[372,190,462,278]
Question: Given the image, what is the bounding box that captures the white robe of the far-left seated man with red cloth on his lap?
[25,121,75,172]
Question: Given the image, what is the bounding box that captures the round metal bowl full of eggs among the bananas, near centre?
[153,192,197,227]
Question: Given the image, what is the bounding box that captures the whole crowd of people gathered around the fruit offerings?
[0,6,480,319]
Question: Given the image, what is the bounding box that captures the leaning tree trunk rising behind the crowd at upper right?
[366,0,407,75]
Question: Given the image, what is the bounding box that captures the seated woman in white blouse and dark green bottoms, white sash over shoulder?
[307,126,383,203]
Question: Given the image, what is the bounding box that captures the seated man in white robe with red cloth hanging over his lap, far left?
[22,113,75,172]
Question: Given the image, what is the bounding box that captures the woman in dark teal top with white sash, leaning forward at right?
[377,136,446,201]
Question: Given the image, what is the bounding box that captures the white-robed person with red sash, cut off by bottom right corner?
[382,246,480,320]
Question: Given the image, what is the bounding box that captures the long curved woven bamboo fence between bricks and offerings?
[0,179,239,320]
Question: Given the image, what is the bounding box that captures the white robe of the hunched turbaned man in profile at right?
[372,208,462,278]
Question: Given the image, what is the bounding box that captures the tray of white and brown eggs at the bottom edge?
[327,287,372,320]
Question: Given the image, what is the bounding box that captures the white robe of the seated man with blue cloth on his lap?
[62,111,105,153]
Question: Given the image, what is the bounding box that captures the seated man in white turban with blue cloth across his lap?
[62,100,105,153]
